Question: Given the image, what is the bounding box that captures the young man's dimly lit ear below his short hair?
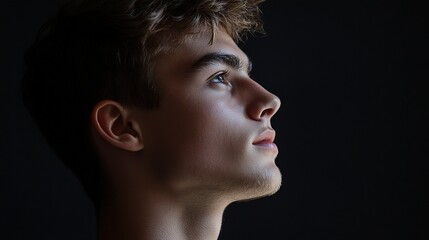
[91,100,143,152]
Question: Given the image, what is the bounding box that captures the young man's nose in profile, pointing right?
[246,82,281,121]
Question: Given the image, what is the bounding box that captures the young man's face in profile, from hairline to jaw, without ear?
[138,29,281,201]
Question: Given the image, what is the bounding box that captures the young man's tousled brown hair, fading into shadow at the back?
[22,0,263,206]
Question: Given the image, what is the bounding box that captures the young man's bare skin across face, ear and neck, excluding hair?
[92,29,281,240]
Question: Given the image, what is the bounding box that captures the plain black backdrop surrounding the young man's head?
[0,0,429,240]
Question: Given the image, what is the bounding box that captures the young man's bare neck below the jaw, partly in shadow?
[98,183,227,240]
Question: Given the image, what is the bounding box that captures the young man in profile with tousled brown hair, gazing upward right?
[23,0,281,240]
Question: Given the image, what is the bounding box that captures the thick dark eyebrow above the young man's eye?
[189,52,252,73]
